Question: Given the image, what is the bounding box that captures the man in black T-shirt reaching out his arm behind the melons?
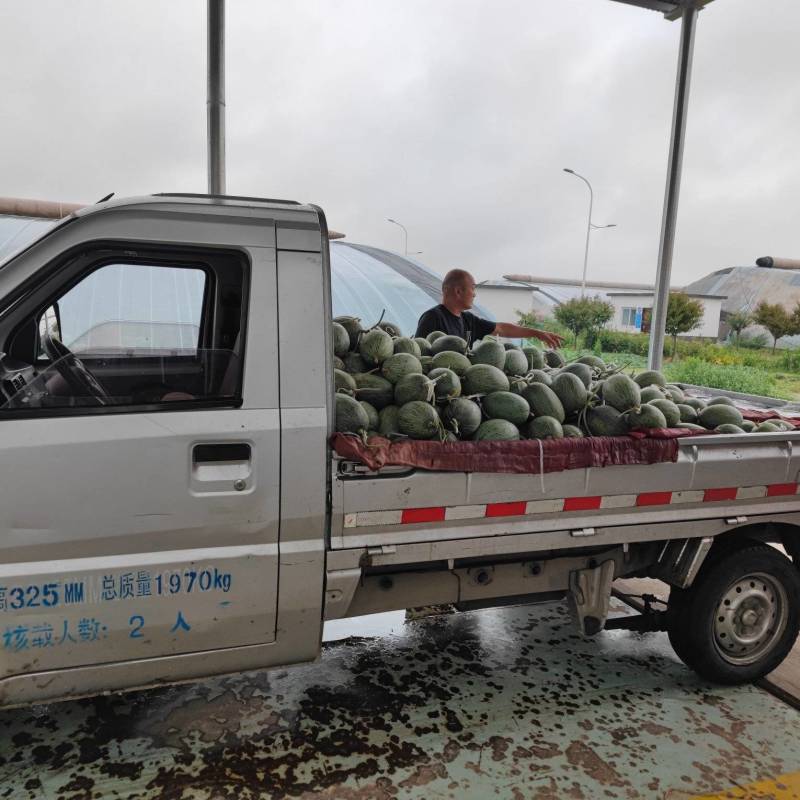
[415,269,563,347]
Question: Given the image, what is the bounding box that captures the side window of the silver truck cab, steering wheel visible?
[0,263,243,409]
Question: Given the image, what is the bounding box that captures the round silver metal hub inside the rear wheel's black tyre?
[714,573,787,665]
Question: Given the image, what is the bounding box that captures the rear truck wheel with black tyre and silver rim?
[669,544,800,684]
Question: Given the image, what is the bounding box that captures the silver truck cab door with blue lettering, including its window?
[0,236,280,704]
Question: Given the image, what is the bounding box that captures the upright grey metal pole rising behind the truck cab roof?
[206,0,225,194]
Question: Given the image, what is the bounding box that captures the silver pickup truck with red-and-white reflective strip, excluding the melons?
[0,195,800,706]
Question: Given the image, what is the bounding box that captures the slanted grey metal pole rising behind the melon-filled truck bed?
[647,4,697,369]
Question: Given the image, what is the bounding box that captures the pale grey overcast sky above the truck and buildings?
[0,0,800,284]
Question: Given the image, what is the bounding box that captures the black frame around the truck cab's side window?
[0,240,252,422]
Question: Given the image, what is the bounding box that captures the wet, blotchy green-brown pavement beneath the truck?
[0,601,800,800]
